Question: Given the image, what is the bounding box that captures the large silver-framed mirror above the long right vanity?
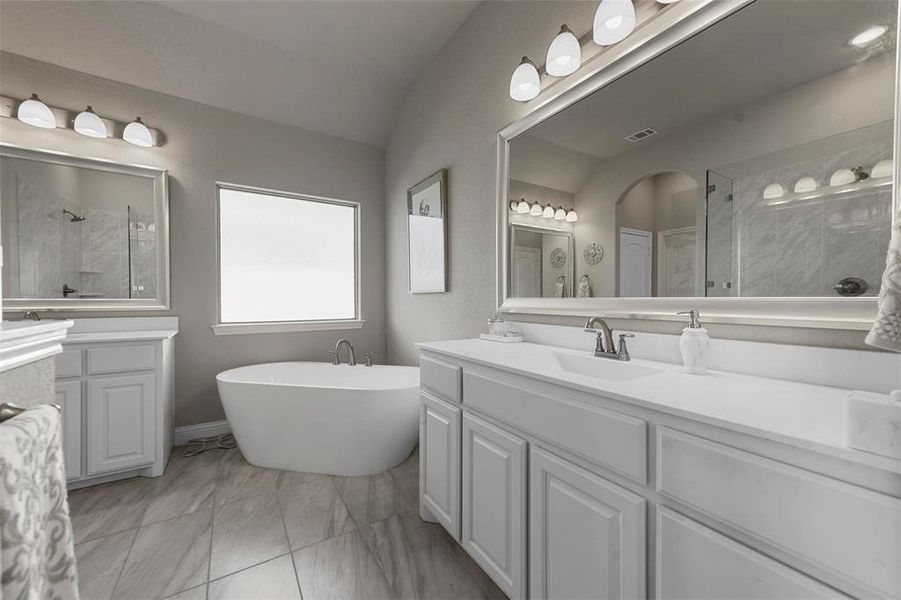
[498,0,898,329]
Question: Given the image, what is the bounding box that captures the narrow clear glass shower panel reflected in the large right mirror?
[705,171,738,298]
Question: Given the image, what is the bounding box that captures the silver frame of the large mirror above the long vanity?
[496,0,901,330]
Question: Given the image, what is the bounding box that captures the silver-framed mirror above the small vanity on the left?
[0,145,169,312]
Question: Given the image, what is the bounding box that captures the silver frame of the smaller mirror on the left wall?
[0,143,170,313]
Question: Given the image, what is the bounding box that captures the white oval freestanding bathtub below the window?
[216,362,419,475]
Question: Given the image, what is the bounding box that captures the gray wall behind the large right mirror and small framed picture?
[385,2,884,364]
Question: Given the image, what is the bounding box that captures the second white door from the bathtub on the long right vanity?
[462,414,526,598]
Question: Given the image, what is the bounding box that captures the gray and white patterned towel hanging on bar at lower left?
[0,405,78,600]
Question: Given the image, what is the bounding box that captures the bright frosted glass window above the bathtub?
[219,187,358,323]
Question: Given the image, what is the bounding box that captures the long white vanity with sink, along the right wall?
[420,340,901,599]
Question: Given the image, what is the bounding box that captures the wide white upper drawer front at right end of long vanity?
[657,427,901,598]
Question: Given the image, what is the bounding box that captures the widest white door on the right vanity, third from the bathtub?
[529,447,646,600]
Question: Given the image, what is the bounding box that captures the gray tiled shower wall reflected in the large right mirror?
[728,141,892,297]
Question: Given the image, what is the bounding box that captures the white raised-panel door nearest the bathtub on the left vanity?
[87,374,155,475]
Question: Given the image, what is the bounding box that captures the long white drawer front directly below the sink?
[463,373,648,483]
